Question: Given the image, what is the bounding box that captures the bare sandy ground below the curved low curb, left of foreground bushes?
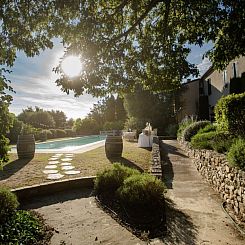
[25,190,146,245]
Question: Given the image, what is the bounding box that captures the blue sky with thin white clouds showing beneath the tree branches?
[8,40,211,119]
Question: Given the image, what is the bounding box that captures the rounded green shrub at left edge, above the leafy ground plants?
[0,188,19,222]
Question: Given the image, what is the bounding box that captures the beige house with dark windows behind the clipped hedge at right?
[177,56,245,122]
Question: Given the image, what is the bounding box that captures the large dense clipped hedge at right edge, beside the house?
[214,93,245,136]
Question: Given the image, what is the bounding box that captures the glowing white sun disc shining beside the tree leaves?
[61,56,82,77]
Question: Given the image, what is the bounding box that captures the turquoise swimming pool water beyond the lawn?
[36,135,106,150]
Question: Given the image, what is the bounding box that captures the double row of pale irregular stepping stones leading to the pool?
[43,153,80,180]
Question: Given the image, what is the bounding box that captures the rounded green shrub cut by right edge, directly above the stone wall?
[227,138,245,169]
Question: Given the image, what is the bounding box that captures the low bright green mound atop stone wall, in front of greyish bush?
[191,131,216,150]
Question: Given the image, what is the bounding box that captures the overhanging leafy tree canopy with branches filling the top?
[0,0,245,95]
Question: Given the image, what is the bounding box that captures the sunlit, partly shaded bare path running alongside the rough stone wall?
[163,140,245,245]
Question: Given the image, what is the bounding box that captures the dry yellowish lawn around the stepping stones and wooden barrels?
[0,141,151,188]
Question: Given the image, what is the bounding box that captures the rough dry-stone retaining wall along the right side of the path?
[179,141,245,221]
